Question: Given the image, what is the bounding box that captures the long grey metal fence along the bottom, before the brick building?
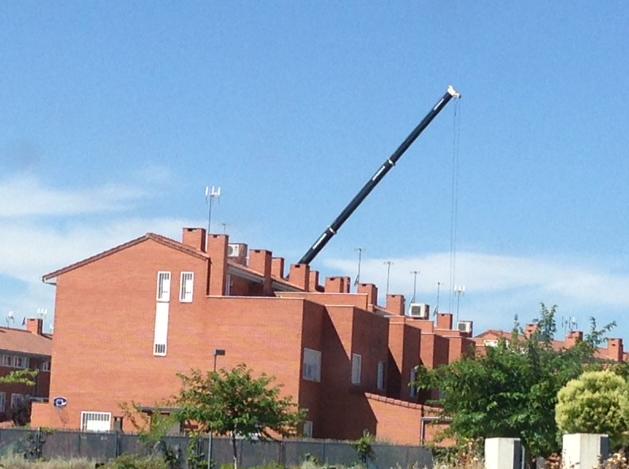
[0,429,433,469]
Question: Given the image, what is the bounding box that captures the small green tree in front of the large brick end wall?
[176,364,304,468]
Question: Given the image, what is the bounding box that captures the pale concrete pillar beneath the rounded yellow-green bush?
[561,433,609,469]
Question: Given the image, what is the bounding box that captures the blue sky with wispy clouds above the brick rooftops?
[0,1,629,338]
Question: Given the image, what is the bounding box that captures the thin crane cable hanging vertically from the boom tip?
[448,99,461,313]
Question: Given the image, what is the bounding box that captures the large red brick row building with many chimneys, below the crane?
[32,228,474,444]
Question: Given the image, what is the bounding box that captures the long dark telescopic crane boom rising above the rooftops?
[299,86,461,264]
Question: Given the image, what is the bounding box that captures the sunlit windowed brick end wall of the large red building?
[33,240,304,428]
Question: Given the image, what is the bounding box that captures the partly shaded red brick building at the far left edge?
[0,319,52,420]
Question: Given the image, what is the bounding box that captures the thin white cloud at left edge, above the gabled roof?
[0,174,144,218]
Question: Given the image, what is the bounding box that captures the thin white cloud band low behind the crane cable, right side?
[326,252,629,308]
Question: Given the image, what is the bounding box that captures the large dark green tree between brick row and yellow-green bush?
[416,304,611,457]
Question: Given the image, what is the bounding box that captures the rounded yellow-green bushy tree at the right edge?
[555,370,629,446]
